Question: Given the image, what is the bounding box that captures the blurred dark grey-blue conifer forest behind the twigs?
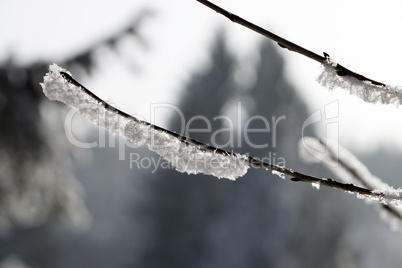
[0,2,402,268]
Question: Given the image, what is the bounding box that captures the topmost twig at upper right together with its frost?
[196,0,402,105]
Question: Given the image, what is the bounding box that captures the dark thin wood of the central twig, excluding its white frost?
[60,72,383,197]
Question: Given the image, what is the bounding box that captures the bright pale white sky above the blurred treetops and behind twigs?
[0,0,402,151]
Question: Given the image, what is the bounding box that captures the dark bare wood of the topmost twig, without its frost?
[196,0,386,87]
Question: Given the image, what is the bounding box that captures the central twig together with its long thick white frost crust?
[41,64,392,202]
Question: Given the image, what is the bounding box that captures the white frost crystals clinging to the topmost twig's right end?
[317,58,402,105]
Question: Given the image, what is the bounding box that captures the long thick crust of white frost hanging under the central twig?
[41,64,249,180]
